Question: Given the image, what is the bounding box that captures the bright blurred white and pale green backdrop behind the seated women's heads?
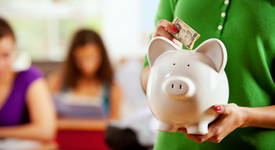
[0,0,159,62]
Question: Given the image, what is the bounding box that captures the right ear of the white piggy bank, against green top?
[195,39,227,72]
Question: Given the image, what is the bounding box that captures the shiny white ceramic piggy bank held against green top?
[146,37,229,135]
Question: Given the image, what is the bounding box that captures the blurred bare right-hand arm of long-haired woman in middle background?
[110,83,121,119]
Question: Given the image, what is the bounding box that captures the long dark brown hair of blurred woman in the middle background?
[63,29,113,88]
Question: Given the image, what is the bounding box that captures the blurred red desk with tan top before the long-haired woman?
[57,119,110,150]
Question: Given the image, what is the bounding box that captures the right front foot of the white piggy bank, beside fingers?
[186,122,208,135]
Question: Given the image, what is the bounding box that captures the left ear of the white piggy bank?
[147,37,180,67]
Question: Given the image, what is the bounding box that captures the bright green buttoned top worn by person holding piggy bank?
[144,0,275,150]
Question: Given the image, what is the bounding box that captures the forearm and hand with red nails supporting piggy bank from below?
[183,104,275,143]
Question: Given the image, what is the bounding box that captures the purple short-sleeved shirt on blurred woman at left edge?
[0,66,42,126]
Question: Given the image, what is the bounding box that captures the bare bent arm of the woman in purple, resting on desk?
[0,78,56,142]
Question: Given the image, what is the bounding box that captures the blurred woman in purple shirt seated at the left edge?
[0,18,55,142]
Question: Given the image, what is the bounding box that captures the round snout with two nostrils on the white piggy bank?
[163,77,195,99]
